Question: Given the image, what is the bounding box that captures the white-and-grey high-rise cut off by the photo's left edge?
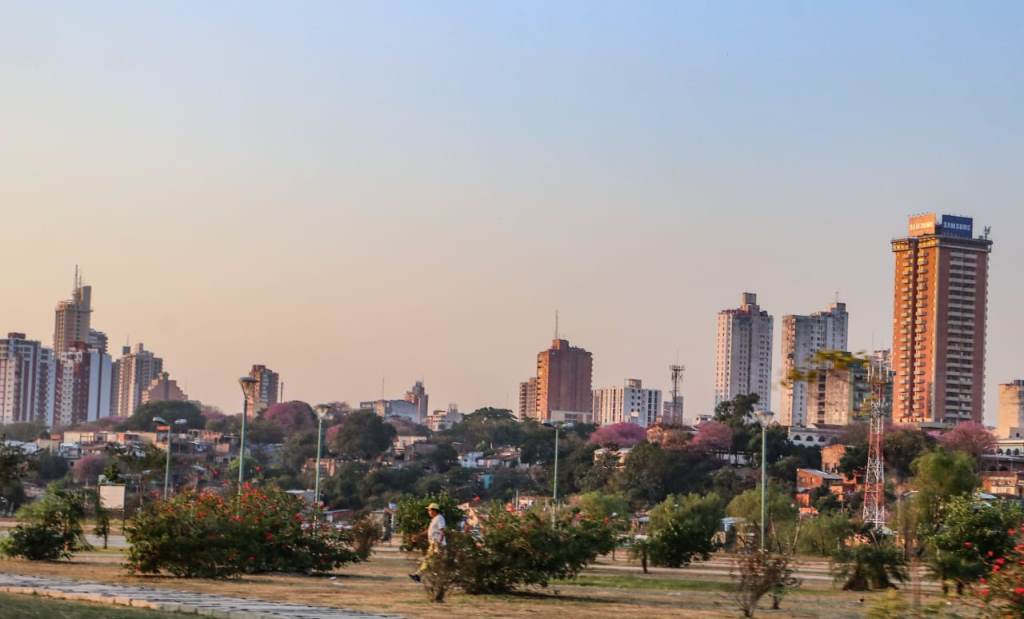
[0,333,56,425]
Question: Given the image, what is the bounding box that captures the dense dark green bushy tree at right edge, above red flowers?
[925,496,1024,592]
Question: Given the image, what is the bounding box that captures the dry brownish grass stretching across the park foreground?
[0,552,966,619]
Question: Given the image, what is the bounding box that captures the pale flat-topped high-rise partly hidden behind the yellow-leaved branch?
[778,302,850,426]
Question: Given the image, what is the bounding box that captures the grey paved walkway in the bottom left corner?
[0,573,393,619]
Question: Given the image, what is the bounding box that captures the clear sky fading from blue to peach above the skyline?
[0,0,1024,423]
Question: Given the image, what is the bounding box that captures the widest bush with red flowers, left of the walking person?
[125,484,360,578]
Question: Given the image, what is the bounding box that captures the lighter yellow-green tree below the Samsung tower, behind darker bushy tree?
[912,449,978,538]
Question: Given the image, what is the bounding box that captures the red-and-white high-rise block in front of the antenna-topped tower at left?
[53,341,113,426]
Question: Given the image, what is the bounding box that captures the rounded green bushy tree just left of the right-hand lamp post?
[647,493,723,568]
